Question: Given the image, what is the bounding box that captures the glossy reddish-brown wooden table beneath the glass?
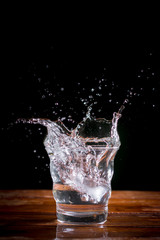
[0,190,160,240]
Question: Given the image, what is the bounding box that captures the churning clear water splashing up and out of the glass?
[17,103,124,203]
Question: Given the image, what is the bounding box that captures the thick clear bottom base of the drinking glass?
[57,204,108,224]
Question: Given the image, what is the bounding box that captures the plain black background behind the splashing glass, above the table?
[0,6,160,190]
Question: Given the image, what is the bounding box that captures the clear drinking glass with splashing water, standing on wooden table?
[43,113,120,224]
